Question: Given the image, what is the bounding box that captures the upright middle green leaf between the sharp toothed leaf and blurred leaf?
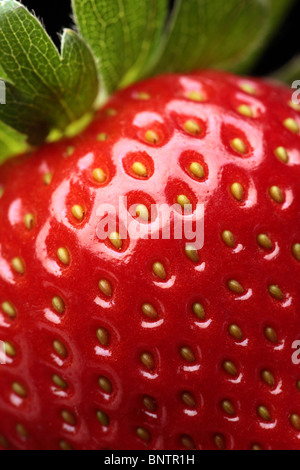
[72,0,168,93]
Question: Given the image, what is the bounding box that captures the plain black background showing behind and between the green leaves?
[23,0,300,75]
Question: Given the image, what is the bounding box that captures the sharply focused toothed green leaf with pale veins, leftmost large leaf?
[0,0,98,144]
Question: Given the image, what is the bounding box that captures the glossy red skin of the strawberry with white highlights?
[0,71,300,450]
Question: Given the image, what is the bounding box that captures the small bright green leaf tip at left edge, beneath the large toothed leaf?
[0,122,28,164]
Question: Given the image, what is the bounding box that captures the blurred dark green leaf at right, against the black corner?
[152,0,292,73]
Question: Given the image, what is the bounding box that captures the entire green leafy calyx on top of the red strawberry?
[0,0,293,163]
